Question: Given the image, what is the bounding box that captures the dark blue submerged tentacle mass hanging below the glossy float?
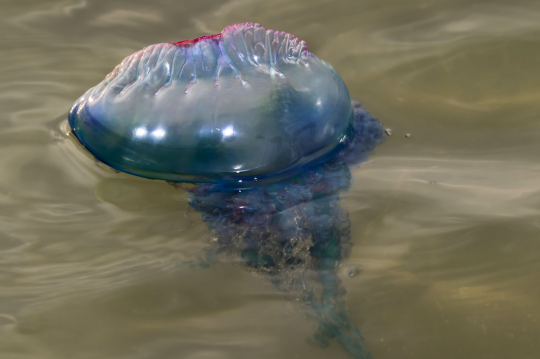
[187,108,382,359]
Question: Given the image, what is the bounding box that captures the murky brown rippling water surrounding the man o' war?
[0,0,540,359]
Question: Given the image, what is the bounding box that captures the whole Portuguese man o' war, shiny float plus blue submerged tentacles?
[68,23,383,359]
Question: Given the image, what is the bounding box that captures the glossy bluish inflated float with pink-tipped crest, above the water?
[69,23,354,186]
